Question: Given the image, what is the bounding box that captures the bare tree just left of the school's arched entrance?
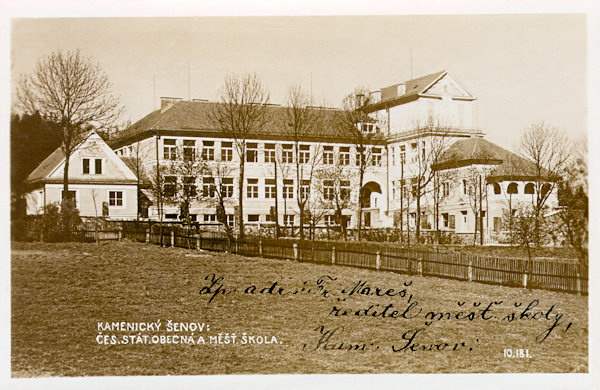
[335,87,385,240]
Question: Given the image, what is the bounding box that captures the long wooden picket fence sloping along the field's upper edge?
[121,231,588,295]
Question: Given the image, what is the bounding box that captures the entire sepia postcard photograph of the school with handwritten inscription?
[6,2,593,388]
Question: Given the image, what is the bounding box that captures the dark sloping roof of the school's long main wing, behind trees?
[111,100,345,148]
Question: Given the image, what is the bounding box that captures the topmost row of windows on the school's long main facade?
[163,139,383,166]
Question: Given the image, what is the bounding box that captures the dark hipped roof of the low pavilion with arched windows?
[433,137,537,182]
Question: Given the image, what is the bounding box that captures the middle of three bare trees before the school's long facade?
[282,85,322,240]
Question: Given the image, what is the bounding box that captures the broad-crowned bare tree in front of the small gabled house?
[17,50,121,209]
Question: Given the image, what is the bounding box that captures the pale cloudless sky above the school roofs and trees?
[11,14,587,149]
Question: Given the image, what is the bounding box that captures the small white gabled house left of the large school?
[25,131,138,219]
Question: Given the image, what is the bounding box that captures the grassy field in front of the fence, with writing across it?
[11,242,588,377]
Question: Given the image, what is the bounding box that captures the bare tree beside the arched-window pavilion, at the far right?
[519,122,570,245]
